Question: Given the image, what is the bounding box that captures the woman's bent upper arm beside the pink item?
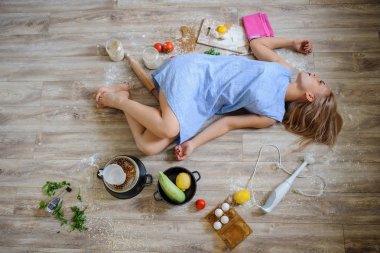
[250,37,312,69]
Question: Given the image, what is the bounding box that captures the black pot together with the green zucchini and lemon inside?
[153,167,201,206]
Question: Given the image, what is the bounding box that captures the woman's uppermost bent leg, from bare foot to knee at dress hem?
[99,92,179,139]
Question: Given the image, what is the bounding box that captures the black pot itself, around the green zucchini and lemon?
[153,167,201,206]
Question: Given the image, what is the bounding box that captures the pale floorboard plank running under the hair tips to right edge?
[243,130,380,164]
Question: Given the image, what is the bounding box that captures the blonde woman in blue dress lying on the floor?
[96,38,343,160]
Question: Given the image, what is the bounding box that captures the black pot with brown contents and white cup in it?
[97,155,153,199]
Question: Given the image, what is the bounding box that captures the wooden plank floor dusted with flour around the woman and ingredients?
[0,0,380,253]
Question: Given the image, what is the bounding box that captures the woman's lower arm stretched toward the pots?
[174,115,276,160]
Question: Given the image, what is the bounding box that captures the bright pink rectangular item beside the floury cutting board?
[242,12,274,41]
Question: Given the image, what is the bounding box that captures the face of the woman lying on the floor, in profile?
[296,71,331,101]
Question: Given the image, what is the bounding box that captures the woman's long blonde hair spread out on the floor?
[282,92,343,150]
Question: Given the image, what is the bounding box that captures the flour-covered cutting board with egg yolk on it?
[197,19,249,54]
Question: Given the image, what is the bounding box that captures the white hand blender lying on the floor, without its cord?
[259,156,315,213]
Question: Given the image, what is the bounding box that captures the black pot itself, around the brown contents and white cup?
[97,155,153,199]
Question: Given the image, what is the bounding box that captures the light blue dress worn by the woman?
[152,54,291,143]
